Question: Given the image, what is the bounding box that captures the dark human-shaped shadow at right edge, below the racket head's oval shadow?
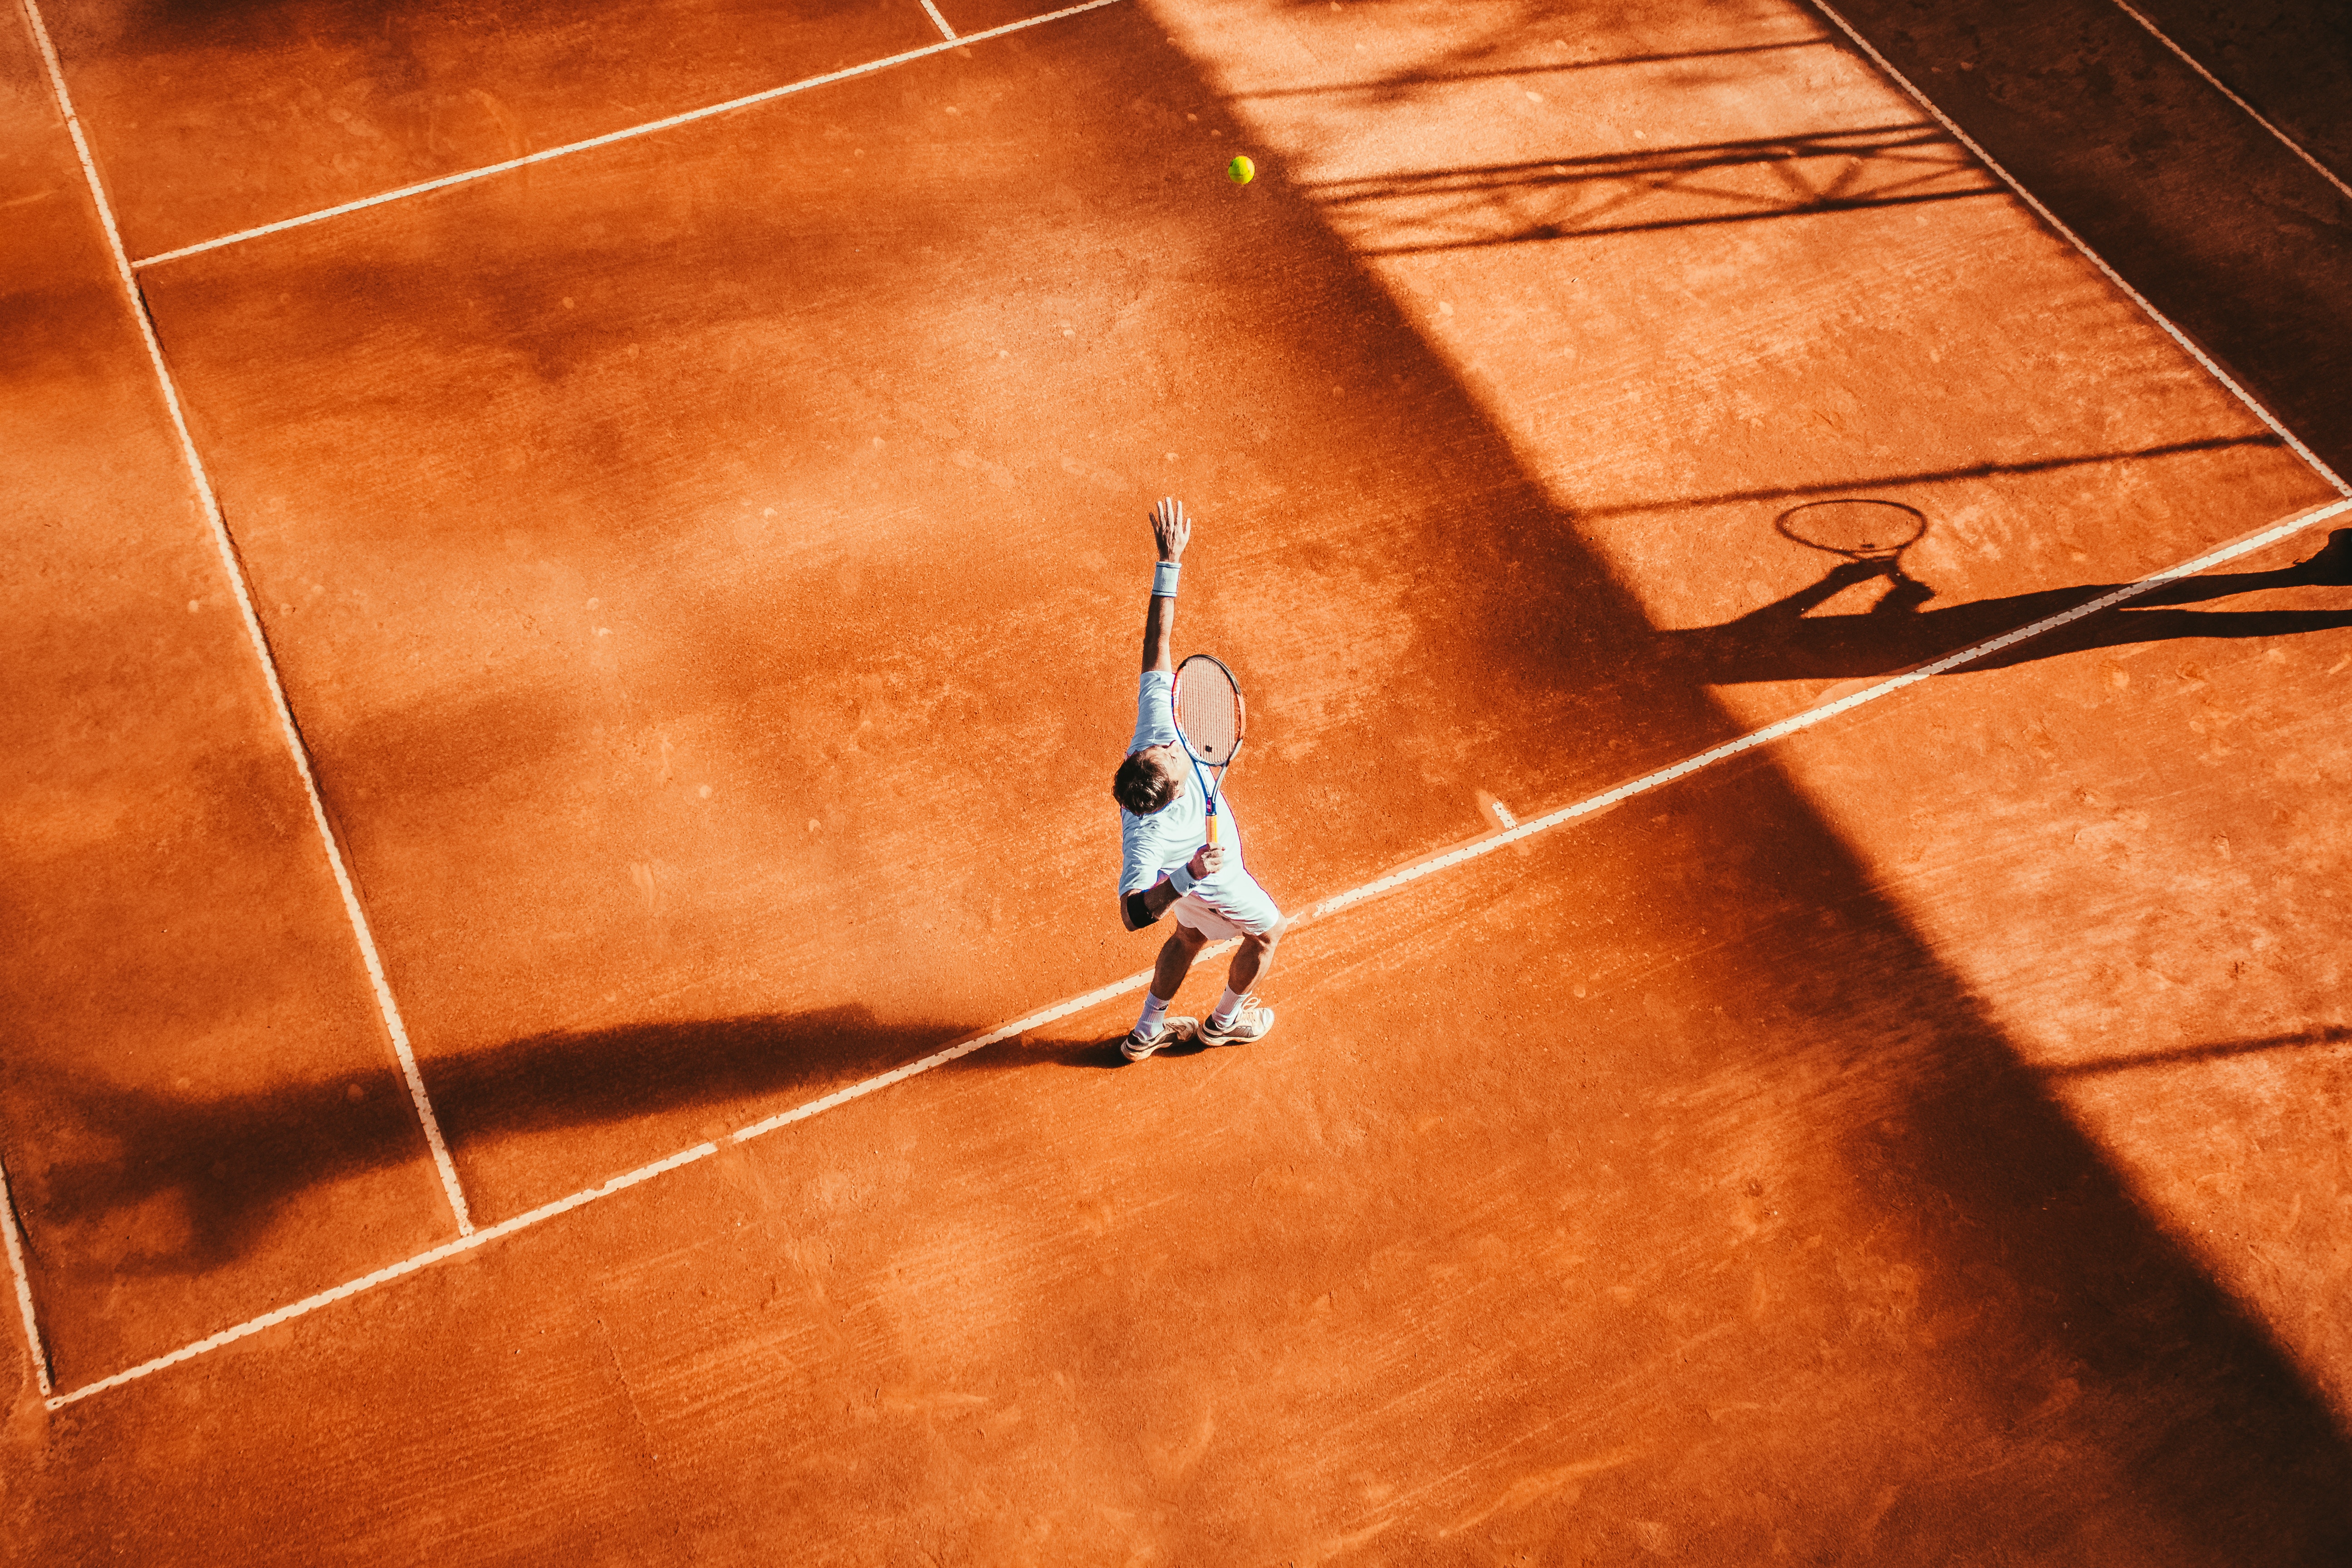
[1656,529,2352,686]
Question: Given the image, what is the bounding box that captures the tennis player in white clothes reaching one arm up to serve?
[1110,501,1282,1063]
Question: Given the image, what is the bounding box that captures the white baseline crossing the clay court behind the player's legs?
[47,498,2352,1411]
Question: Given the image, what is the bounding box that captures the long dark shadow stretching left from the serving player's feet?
[27,1006,971,1274]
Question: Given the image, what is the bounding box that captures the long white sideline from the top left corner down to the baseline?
[24,0,473,1236]
